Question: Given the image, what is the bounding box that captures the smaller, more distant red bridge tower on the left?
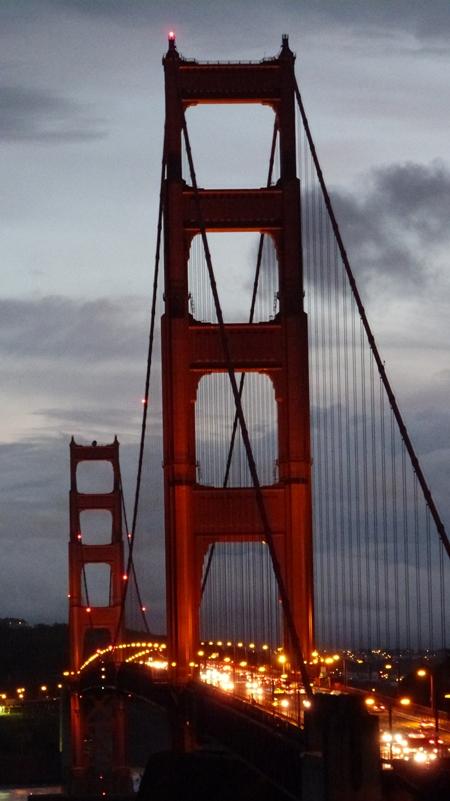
[69,438,129,795]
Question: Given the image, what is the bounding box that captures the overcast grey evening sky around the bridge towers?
[0,0,450,628]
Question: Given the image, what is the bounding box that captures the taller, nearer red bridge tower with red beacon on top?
[162,37,313,682]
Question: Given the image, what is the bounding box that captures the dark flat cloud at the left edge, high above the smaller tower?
[0,85,106,144]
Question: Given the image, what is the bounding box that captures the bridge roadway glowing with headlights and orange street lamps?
[75,641,450,766]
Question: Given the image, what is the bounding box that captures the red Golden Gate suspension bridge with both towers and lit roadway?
[64,34,450,799]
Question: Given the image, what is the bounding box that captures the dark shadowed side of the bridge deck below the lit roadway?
[78,658,305,801]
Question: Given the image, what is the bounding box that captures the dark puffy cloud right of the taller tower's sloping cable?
[332,160,450,293]
